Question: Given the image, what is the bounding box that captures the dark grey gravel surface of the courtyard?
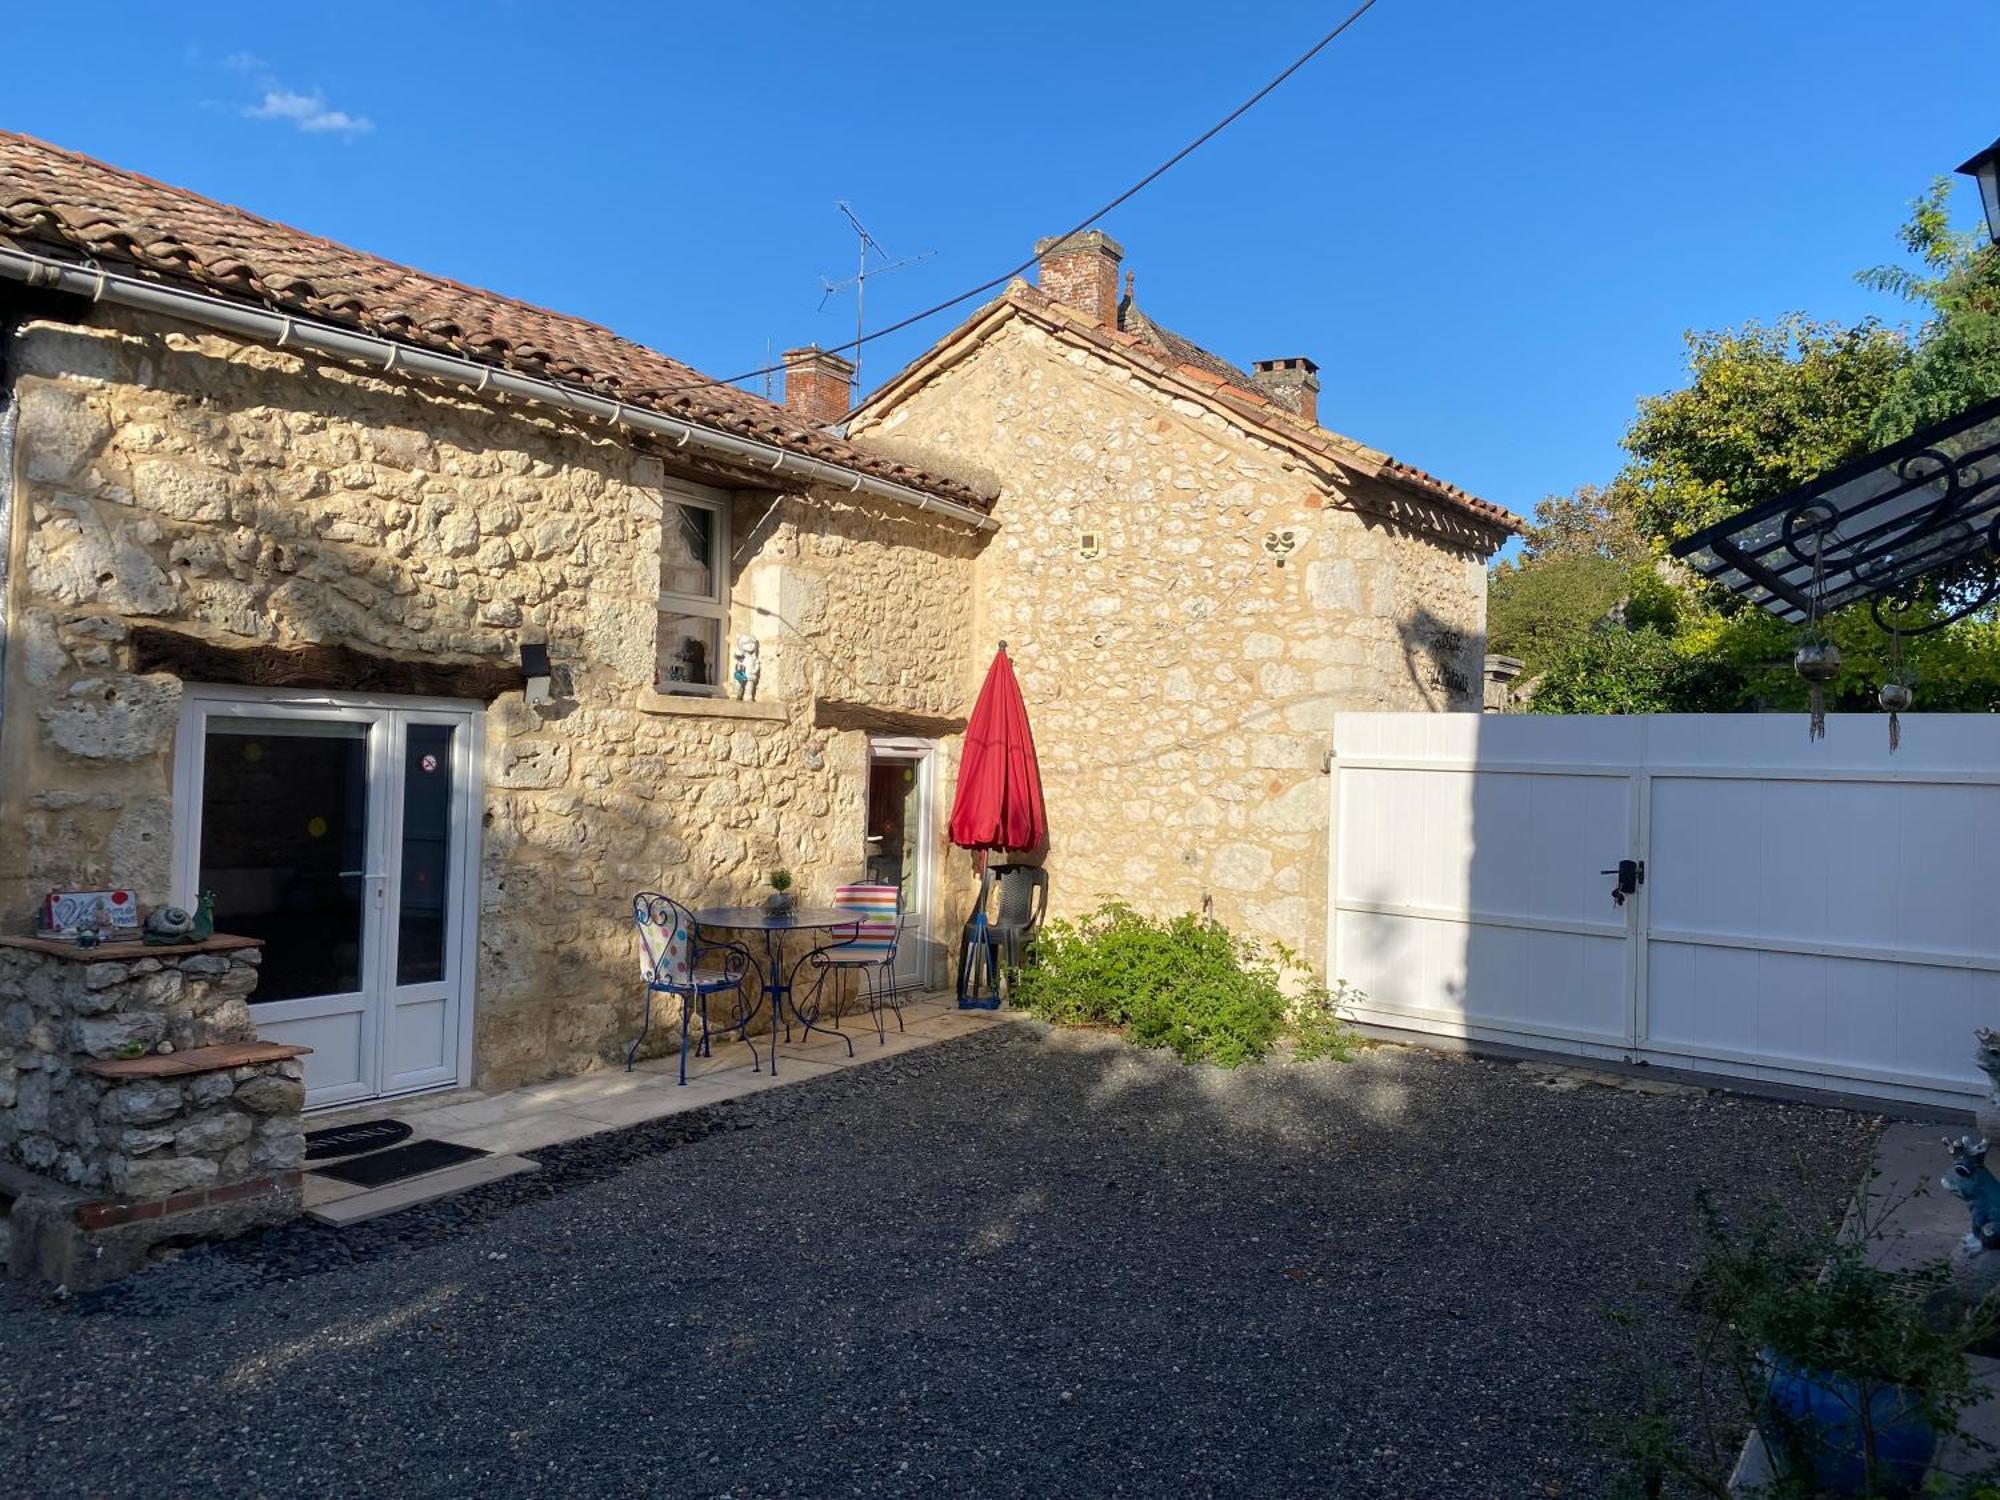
[0,1024,1874,1500]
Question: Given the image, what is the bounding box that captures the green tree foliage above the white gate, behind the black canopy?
[1488,180,2000,714]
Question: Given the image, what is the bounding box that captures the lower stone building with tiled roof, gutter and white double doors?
[0,136,992,1120]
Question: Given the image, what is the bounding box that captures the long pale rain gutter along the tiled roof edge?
[0,244,1000,532]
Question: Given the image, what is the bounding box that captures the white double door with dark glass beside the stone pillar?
[174,688,480,1106]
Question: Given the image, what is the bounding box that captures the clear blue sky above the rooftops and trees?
[0,0,2000,528]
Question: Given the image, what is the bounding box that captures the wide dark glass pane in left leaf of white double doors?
[198,716,368,1006]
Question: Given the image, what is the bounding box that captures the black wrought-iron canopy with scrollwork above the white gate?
[1670,390,2000,634]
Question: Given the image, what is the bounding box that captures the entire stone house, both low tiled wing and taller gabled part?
[0,136,1514,1152]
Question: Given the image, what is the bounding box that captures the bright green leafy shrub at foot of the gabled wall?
[1014,902,1348,1068]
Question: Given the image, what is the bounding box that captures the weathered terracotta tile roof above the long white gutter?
[0,132,990,510]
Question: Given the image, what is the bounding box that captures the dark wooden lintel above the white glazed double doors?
[132,626,522,704]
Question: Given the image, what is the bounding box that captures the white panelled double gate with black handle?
[1328,714,2000,1106]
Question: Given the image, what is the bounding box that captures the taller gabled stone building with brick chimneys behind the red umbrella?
[846,230,1518,960]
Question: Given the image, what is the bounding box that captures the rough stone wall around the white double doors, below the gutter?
[0,310,980,1086]
